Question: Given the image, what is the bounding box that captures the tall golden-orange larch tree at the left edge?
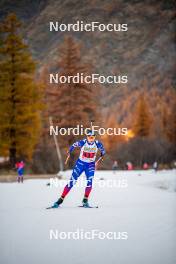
[0,14,42,166]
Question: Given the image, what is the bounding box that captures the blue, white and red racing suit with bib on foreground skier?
[61,139,105,198]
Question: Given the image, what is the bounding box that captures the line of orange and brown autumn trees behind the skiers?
[0,14,176,173]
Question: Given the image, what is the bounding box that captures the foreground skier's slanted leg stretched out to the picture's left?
[57,160,84,204]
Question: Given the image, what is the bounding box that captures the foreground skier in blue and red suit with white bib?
[48,130,105,208]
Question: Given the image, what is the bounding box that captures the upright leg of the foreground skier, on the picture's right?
[83,162,95,204]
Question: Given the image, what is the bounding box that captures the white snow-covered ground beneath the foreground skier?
[0,170,176,264]
